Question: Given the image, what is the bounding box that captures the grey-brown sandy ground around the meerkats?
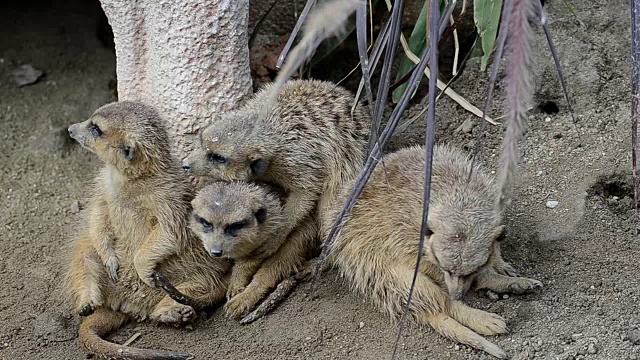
[0,0,640,360]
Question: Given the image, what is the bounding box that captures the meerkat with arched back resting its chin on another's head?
[185,81,369,317]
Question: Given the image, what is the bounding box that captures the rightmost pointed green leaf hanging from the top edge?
[473,0,502,71]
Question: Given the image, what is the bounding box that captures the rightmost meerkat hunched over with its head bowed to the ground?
[325,145,542,359]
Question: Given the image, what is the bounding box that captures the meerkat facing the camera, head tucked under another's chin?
[191,181,318,319]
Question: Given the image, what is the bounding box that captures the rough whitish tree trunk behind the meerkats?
[101,0,252,158]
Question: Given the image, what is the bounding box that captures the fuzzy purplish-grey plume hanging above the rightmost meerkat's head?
[496,0,534,214]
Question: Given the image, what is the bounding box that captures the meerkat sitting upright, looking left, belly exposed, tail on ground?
[66,102,230,359]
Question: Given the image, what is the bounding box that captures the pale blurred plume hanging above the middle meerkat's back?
[266,0,362,111]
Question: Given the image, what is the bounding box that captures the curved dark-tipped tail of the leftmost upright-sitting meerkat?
[78,308,192,360]
